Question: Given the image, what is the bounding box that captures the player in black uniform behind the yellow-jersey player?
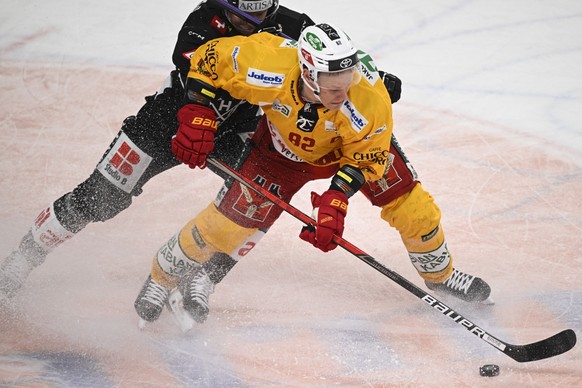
[0,0,314,298]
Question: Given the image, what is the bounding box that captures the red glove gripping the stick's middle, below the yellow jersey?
[299,190,348,252]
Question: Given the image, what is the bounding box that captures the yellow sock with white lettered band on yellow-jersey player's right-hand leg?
[382,184,453,283]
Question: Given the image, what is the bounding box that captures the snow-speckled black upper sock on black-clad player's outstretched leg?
[54,170,132,233]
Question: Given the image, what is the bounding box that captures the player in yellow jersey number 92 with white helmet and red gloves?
[136,24,491,322]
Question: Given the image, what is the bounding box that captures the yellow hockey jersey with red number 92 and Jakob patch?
[188,33,393,181]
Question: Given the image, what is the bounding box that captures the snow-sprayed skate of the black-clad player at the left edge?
[0,232,46,298]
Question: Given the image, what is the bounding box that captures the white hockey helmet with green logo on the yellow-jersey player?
[298,23,358,83]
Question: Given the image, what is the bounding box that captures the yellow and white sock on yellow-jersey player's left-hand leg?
[151,203,265,287]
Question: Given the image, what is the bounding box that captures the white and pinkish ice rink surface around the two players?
[0,0,582,387]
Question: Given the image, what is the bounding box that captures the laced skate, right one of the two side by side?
[178,267,214,323]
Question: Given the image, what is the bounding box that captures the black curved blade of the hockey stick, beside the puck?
[503,329,576,362]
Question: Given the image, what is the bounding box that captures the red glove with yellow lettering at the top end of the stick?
[172,104,217,168]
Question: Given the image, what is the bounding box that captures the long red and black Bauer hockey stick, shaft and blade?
[207,158,576,362]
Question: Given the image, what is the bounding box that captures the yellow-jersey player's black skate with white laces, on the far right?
[424,269,494,304]
